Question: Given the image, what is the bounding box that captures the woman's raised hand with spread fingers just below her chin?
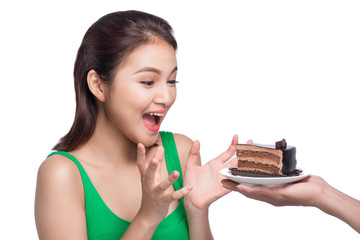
[137,143,192,224]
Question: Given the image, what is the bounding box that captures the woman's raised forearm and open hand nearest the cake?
[177,136,237,239]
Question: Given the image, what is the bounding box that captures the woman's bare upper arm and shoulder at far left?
[35,155,87,240]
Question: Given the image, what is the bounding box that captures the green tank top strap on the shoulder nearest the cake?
[160,131,183,190]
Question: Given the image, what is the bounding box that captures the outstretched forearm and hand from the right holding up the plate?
[222,176,360,233]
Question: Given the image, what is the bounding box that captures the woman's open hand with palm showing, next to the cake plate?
[184,135,238,214]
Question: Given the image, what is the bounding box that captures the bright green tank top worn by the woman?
[49,132,189,240]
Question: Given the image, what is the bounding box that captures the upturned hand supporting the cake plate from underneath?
[222,176,327,206]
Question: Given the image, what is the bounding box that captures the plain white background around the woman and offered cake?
[0,0,360,239]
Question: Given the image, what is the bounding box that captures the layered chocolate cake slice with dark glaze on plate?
[236,139,296,176]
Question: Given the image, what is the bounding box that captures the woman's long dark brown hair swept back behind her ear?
[54,11,177,151]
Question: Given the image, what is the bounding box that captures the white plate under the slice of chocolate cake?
[220,168,310,187]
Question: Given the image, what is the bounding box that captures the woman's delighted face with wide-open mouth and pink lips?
[105,40,177,146]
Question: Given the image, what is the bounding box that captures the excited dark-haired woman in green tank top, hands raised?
[35,11,237,239]
